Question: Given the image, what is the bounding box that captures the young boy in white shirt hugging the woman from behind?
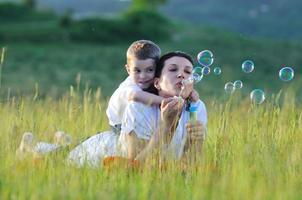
[106,40,163,133]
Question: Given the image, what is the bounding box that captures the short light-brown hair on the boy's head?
[127,40,161,63]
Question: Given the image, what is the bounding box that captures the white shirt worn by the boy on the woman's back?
[106,76,142,126]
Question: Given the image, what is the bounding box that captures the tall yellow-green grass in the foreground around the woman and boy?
[0,89,302,199]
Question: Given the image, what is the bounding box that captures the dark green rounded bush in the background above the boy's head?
[70,10,173,43]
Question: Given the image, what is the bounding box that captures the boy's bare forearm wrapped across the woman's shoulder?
[128,91,164,105]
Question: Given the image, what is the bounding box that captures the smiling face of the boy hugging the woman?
[126,58,156,89]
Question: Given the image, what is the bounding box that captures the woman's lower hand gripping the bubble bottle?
[186,121,206,141]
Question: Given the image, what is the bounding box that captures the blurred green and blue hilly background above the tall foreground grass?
[0,0,302,99]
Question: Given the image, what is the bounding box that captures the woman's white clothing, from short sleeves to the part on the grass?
[68,101,207,167]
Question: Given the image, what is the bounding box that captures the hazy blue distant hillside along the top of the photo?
[39,0,302,40]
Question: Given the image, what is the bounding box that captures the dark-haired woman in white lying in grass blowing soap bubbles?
[68,52,207,167]
